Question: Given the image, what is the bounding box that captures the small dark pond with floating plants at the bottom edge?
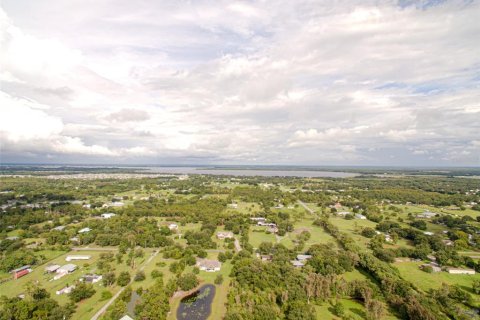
[177,284,215,320]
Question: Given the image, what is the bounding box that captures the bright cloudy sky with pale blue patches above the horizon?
[0,0,480,166]
